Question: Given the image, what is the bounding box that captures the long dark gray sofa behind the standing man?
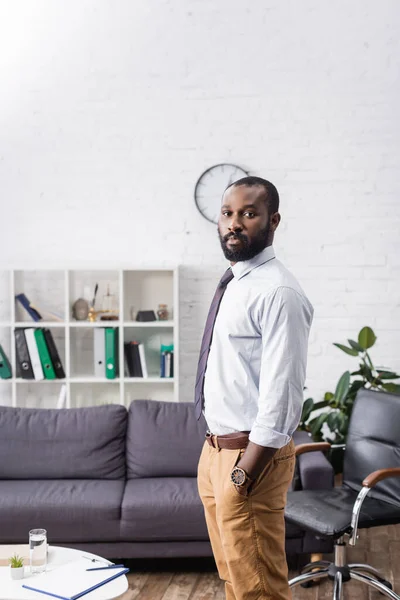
[0,400,333,558]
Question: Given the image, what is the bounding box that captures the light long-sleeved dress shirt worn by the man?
[204,246,313,448]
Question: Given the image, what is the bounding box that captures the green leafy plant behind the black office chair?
[299,327,400,473]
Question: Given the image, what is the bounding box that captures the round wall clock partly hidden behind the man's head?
[194,163,248,223]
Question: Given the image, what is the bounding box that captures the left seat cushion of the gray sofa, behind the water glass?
[0,479,125,544]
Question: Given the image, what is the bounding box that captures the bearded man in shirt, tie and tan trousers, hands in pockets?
[196,177,313,600]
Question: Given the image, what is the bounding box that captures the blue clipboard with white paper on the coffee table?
[22,560,129,600]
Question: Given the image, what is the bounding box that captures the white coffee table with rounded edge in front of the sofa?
[0,546,128,600]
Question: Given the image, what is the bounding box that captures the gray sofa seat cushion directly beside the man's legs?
[121,477,208,542]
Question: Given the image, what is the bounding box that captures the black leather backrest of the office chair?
[343,389,400,506]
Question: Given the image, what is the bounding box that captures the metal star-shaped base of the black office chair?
[289,538,400,600]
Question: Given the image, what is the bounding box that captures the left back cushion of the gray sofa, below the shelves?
[0,405,127,479]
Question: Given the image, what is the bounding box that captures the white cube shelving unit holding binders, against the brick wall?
[0,268,179,408]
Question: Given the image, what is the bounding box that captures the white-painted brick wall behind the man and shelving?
[0,0,400,408]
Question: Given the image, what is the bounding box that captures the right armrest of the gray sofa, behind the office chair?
[293,432,335,490]
